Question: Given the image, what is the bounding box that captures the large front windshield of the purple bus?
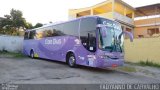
[99,19,124,52]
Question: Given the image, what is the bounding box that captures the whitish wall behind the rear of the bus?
[0,35,23,52]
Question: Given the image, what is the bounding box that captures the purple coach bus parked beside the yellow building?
[23,16,133,68]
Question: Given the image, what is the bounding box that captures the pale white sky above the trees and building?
[0,0,160,25]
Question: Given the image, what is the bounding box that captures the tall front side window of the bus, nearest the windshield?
[80,18,97,52]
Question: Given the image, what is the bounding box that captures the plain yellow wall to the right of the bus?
[124,37,160,64]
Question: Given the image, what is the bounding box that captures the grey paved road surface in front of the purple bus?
[0,58,160,84]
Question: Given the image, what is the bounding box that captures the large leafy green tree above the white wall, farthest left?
[0,9,28,35]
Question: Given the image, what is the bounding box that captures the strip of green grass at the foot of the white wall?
[0,51,26,58]
